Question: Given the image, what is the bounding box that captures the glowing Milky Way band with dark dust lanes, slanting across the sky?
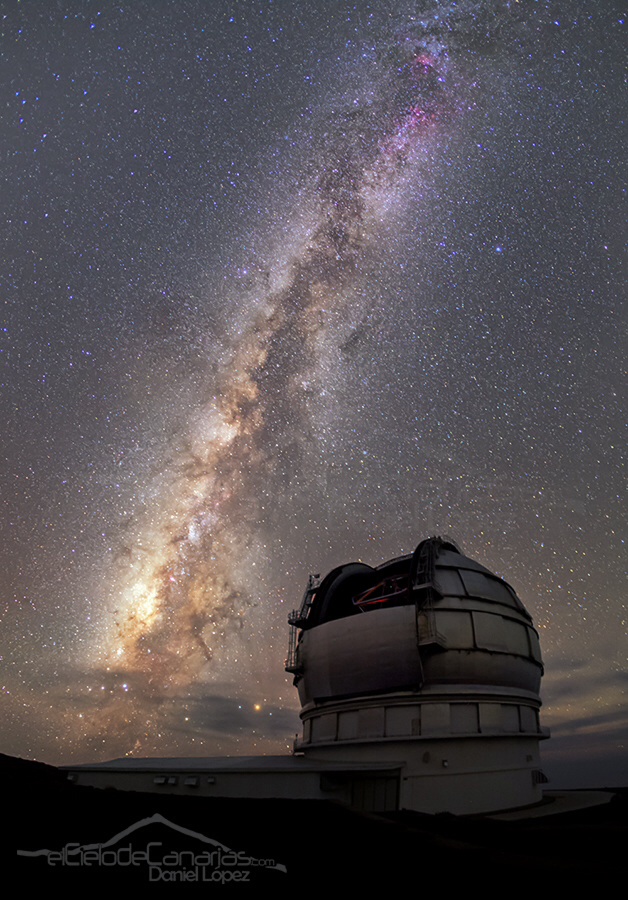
[92,24,462,749]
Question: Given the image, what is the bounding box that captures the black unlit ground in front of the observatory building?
[8,755,628,897]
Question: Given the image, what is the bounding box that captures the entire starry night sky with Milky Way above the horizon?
[0,0,628,784]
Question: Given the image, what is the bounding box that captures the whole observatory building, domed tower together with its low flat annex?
[65,537,548,814]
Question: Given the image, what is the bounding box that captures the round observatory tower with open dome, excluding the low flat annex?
[286,537,547,812]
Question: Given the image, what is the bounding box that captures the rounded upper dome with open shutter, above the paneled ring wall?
[287,537,543,705]
